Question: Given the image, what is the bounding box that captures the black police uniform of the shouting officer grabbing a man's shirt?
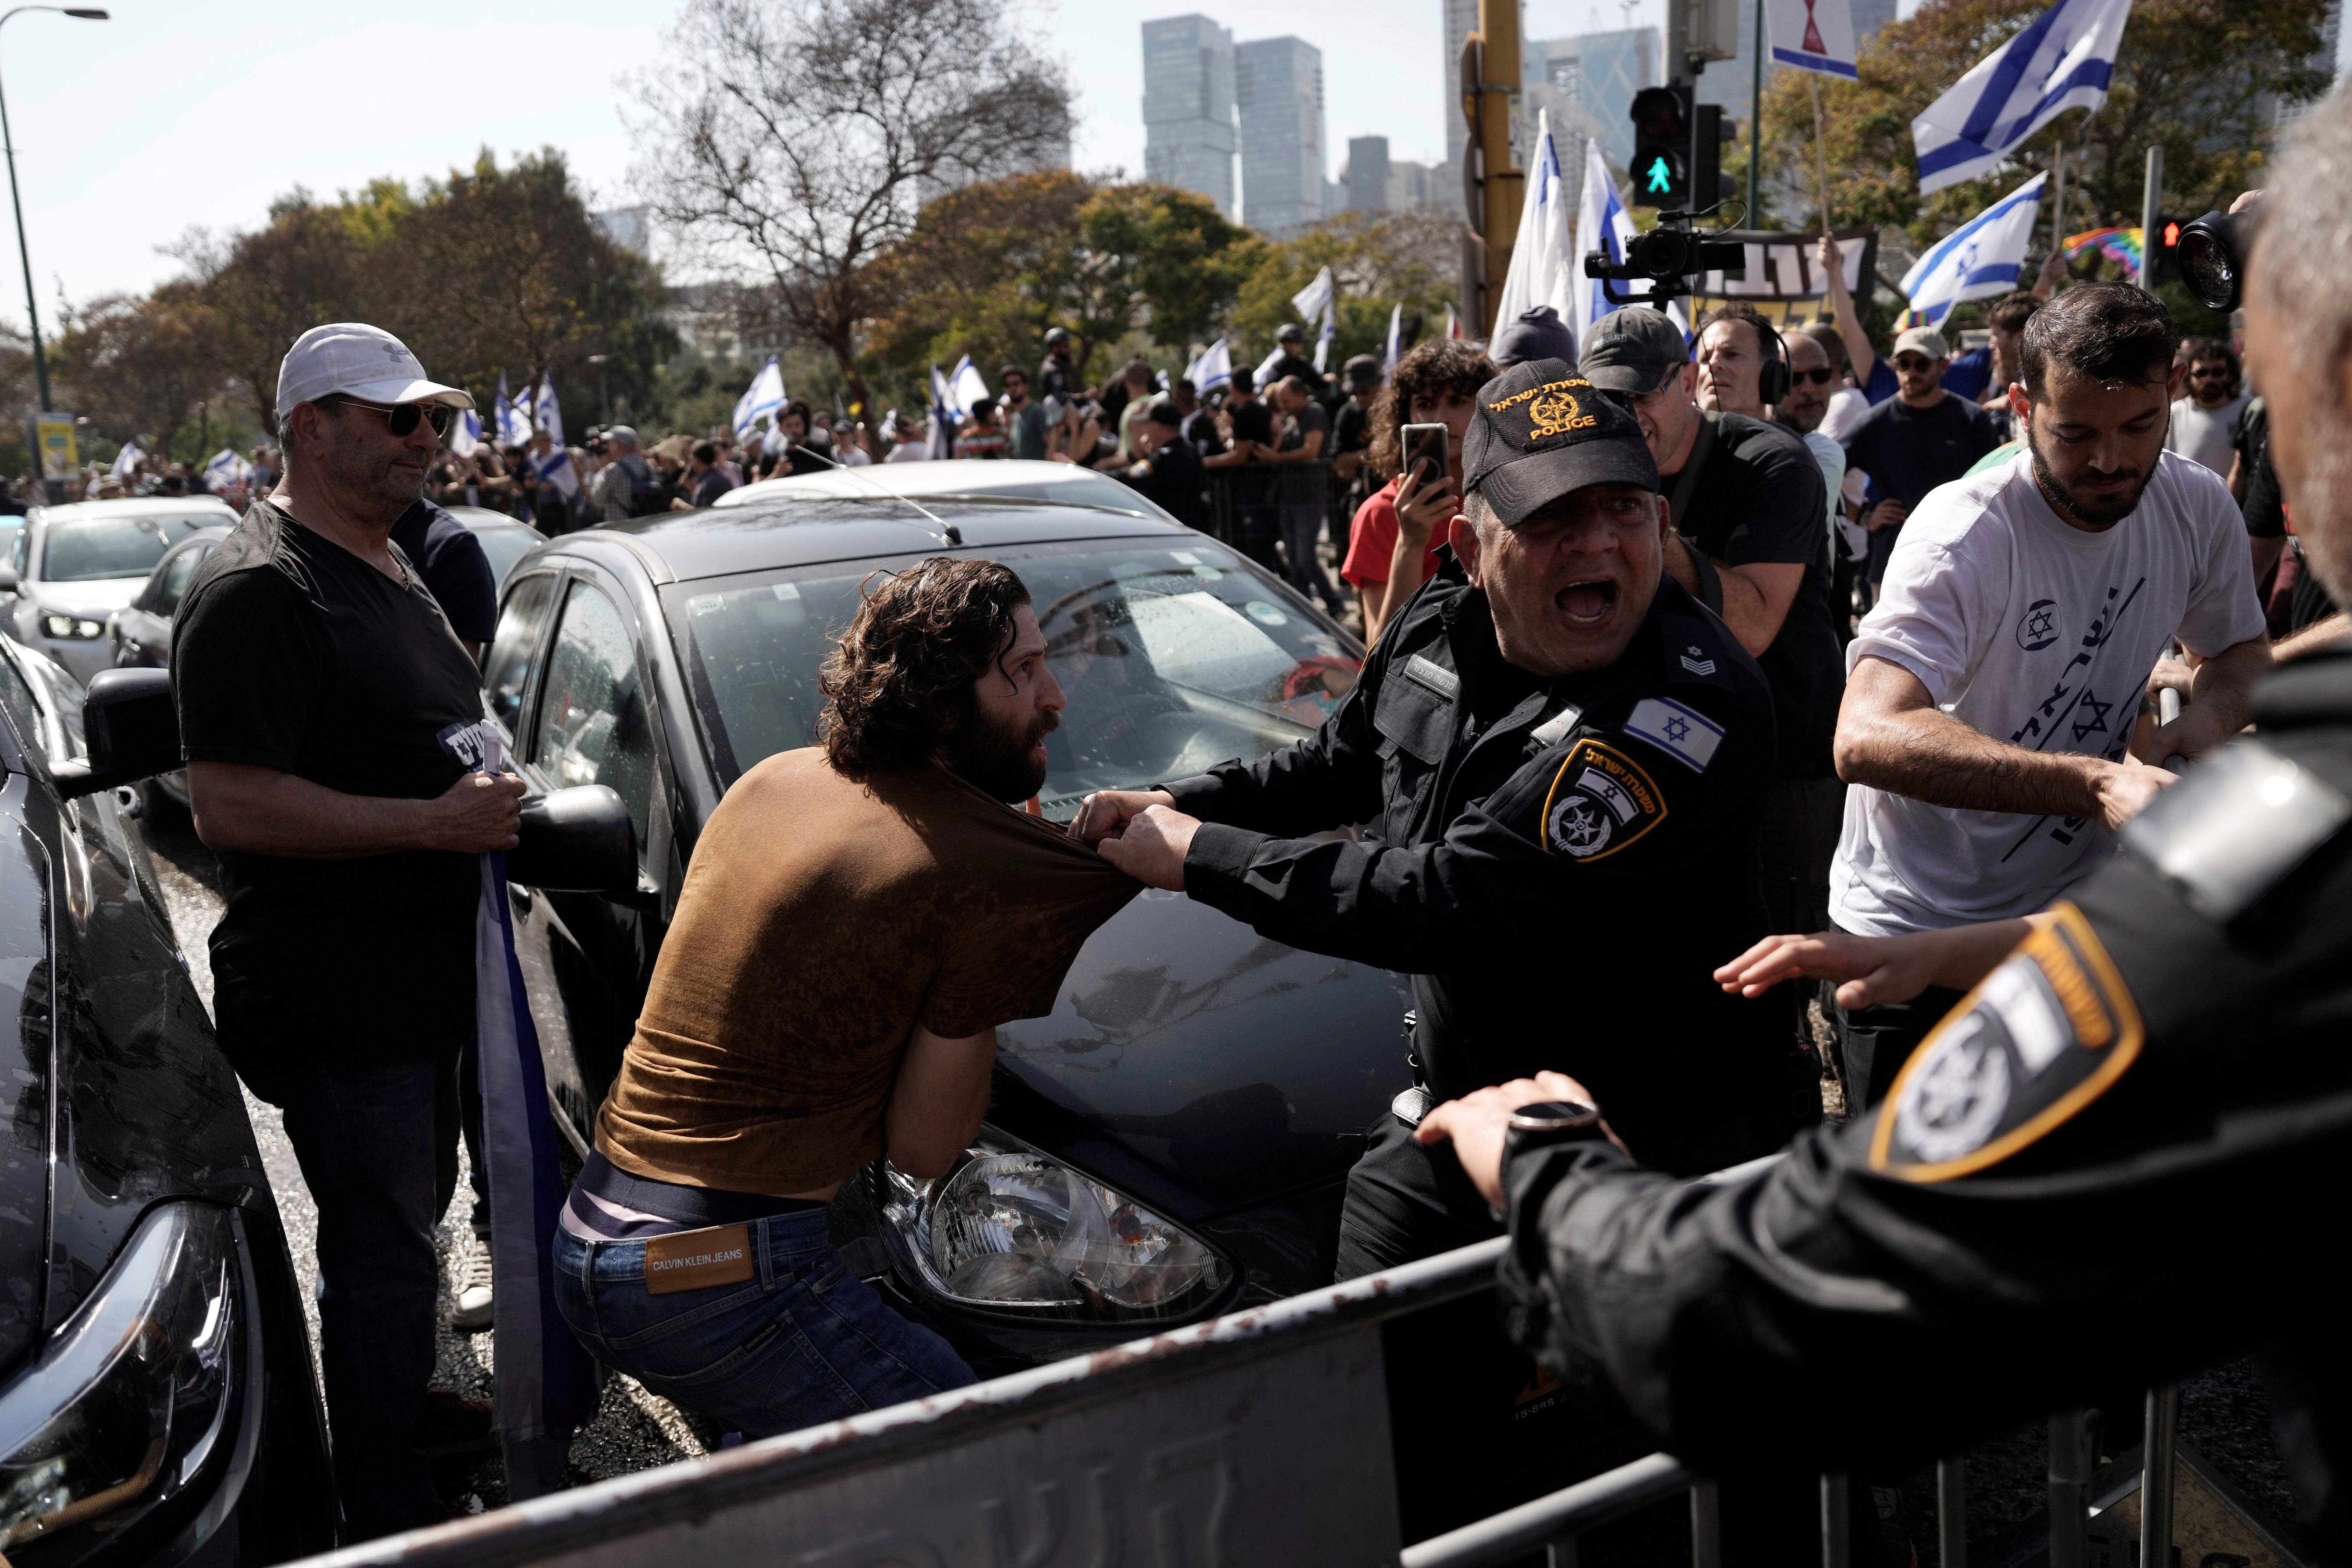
[1164,362,1818,1279]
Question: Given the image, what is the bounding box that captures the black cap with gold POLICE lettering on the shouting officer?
[1463,355,1663,527]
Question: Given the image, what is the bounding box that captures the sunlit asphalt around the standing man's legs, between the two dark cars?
[143,823,717,1511]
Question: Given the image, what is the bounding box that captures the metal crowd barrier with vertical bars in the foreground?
[284,1189,2178,1568]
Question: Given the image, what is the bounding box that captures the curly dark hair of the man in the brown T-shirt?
[816,555,1030,778]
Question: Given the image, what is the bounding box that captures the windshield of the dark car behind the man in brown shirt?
[668,541,1362,820]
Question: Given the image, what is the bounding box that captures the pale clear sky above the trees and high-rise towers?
[0,0,1994,324]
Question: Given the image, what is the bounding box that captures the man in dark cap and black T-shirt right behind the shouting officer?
[1583,305,1846,931]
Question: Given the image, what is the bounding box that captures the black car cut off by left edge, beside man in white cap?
[0,635,336,1566]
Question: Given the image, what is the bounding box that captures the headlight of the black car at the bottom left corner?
[0,1204,245,1566]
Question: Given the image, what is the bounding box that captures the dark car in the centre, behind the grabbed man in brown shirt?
[485,491,1411,1370]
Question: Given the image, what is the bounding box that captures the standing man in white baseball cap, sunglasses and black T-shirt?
[172,322,522,1540]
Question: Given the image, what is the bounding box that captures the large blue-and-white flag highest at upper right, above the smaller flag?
[1912,0,2131,195]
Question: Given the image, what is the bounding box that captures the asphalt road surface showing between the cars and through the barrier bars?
[128,823,2293,1568]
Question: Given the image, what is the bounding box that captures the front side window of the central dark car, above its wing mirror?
[529,583,654,853]
